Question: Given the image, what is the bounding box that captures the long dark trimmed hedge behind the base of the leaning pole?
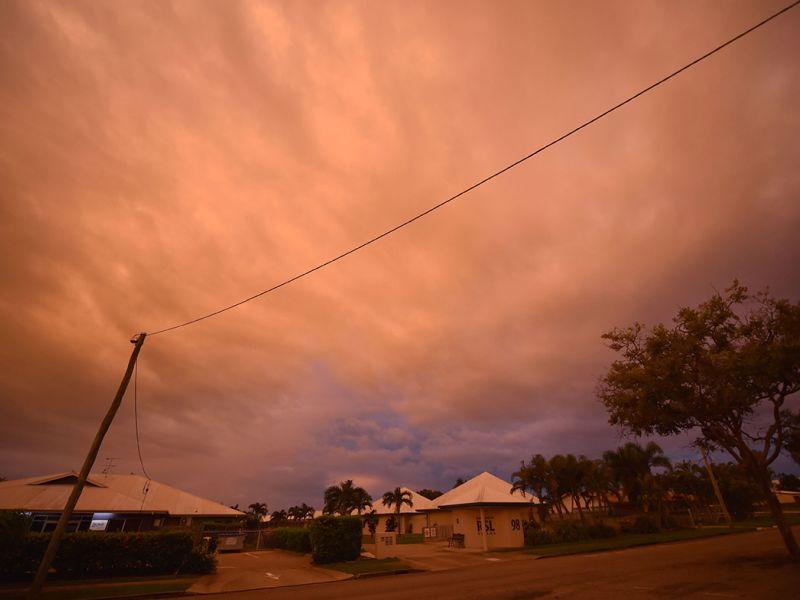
[0,531,216,579]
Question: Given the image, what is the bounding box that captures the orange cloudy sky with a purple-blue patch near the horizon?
[0,0,800,510]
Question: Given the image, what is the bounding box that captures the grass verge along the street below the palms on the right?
[526,515,800,558]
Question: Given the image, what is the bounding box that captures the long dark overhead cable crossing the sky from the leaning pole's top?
[149,0,800,335]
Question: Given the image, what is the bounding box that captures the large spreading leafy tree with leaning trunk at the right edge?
[598,281,800,560]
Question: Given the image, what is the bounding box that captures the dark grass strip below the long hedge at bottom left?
[0,576,197,600]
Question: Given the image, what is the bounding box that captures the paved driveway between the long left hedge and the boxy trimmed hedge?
[187,550,352,594]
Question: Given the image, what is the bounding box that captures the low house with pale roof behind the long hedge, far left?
[0,472,244,532]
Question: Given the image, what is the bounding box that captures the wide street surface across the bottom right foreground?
[207,528,800,600]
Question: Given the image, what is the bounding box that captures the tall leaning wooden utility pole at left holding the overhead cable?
[28,333,147,598]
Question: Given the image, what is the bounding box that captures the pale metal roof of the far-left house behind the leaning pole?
[0,472,243,517]
